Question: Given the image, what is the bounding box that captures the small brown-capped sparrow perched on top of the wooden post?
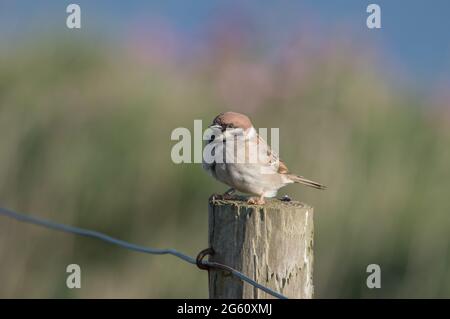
[202,112,326,205]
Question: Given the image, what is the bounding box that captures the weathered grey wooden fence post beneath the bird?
[209,198,314,299]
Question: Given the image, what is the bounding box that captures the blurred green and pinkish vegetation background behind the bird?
[0,29,450,298]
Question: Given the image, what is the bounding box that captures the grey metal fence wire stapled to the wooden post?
[0,207,287,299]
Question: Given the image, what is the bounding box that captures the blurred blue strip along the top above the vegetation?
[0,0,450,89]
